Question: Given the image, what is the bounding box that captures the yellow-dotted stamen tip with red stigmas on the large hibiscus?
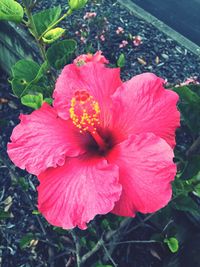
[69,90,100,134]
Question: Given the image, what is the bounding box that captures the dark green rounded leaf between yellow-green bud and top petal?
[46,39,77,69]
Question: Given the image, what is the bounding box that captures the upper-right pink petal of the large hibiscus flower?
[113,73,180,147]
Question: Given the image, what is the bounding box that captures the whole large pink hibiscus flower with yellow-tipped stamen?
[8,52,180,229]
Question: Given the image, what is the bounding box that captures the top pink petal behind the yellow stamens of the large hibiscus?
[53,62,122,126]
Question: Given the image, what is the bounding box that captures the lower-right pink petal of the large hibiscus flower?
[107,133,176,216]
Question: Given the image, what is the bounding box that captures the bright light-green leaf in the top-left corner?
[0,0,24,22]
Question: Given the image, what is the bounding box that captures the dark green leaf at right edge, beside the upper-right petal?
[173,86,200,134]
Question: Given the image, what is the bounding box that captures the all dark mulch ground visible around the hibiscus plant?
[0,0,200,267]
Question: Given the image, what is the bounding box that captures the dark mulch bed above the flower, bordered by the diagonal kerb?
[34,0,200,83]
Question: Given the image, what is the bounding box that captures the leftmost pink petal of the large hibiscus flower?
[8,103,84,175]
